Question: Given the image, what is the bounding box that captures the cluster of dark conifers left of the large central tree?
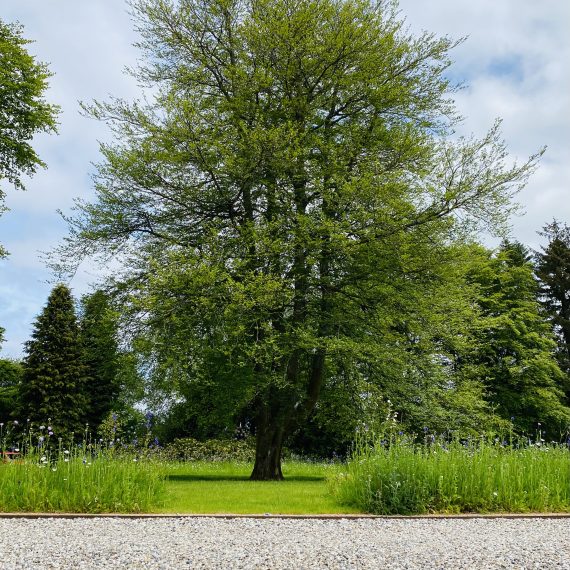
[0,284,133,437]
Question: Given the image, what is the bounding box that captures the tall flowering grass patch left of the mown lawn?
[0,422,166,513]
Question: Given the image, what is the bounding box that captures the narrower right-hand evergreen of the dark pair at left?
[80,291,119,428]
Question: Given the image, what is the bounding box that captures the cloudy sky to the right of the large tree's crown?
[400,0,570,244]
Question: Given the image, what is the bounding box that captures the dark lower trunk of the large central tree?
[250,409,285,481]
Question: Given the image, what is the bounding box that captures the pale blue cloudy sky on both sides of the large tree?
[0,0,570,357]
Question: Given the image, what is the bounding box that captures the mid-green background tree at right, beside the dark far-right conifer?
[466,242,570,439]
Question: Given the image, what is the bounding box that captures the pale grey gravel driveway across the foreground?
[0,517,570,570]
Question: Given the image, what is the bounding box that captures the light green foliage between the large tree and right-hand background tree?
[290,244,502,446]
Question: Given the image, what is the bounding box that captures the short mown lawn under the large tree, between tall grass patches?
[154,461,360,514]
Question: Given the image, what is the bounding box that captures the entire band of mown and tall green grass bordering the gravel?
[6,438,570,515]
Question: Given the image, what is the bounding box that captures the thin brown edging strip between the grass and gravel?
[0,513,570,520]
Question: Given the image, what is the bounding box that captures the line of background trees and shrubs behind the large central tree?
[0,222,570,457]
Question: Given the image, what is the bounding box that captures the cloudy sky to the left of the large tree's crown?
[0,0,138,356]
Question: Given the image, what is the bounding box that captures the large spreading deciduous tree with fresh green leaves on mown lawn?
[55,0,537,479]
